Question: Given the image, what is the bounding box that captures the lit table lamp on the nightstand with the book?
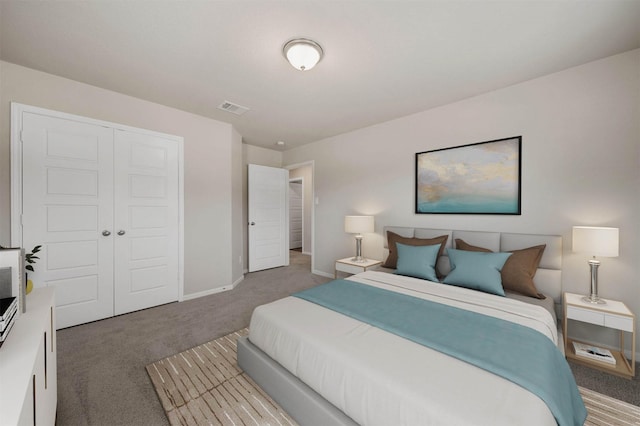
[573,226,619,305]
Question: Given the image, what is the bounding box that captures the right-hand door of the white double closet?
[113,130,180,315]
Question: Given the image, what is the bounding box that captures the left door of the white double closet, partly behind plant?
[21,113,114,328]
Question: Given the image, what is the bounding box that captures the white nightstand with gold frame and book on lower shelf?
[562,293,636,379]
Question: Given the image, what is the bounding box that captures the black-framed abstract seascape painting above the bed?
[415,136,522,215]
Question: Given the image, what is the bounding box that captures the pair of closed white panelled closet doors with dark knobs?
[21,112,180,328]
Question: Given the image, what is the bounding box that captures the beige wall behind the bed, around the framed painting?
[283,50,640,354]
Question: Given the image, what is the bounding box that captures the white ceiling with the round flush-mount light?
[0,0,640,149]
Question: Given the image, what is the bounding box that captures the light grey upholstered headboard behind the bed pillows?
[383,226,562,311]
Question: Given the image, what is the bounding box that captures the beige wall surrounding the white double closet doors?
[0,62,242,295]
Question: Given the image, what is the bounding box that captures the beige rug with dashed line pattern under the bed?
[147,328,640,426]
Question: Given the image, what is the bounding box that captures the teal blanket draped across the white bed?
[293,280,587,426]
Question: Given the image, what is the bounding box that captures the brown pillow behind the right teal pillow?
[456,238,547,299]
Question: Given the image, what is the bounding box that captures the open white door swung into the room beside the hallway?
[248,164,289,272]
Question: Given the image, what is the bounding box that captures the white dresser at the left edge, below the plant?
[0,287,58,426]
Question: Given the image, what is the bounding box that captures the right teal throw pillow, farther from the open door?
[443,249,511,296]
